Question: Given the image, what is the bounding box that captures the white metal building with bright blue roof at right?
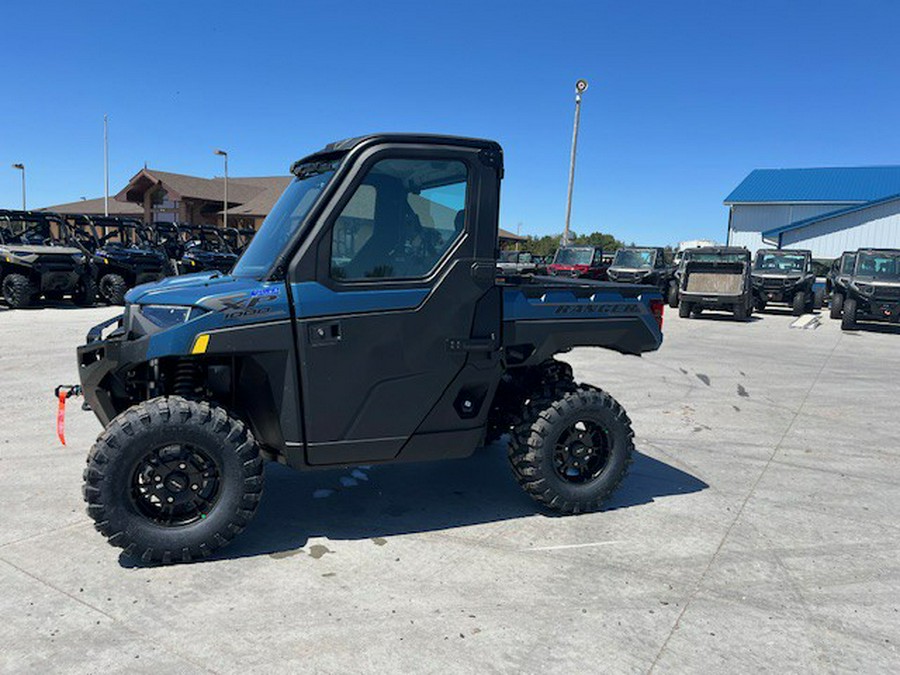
[725,166,900,259]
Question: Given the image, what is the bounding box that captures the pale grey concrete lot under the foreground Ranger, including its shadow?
[0,307,900,673]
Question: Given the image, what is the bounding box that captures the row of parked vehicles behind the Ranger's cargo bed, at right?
[498,246,900,330]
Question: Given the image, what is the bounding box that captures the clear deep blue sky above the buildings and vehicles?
[0,0,900,244]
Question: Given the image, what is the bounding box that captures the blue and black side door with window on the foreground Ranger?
[291,145,500,465]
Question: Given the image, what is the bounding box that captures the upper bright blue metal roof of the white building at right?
[725,166,900,204]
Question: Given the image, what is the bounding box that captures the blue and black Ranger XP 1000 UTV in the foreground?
[78,134,663,562]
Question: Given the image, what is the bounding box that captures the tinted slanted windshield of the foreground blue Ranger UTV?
[232,160,338,278]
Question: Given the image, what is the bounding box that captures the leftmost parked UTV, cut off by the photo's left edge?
[0,210,96,308]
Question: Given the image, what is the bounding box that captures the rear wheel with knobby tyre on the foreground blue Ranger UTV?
[509,385,634,514]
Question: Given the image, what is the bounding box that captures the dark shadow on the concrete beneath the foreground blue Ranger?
[119,444,708,568]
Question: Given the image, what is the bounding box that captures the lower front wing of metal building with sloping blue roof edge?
[782,201,900,258]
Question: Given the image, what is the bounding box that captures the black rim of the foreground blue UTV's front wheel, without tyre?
[131,443,221,527]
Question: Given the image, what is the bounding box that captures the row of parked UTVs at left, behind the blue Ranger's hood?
[0,210,254,308]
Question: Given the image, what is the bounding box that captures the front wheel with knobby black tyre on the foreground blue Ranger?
[84,396,263,563]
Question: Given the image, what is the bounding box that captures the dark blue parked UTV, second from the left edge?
[67,215,170,305]
